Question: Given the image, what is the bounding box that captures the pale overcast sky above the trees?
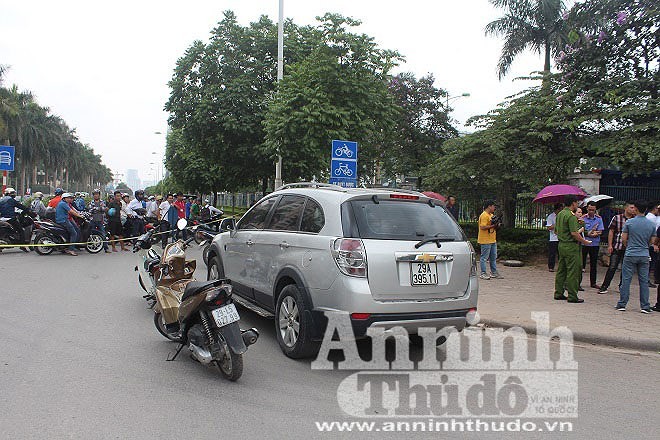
[0,0,543,186]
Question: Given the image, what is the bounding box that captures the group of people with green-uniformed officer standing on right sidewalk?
[546,196,660,313]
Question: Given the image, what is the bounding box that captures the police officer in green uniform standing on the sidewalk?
[555,196,591,303]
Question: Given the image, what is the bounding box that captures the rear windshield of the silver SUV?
[342,199,465,241]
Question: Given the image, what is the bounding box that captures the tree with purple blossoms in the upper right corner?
[557,0,660,172]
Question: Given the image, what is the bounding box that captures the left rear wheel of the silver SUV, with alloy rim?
[275,284,316,359]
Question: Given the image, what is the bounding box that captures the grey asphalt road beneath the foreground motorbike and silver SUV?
[0,246,660,439]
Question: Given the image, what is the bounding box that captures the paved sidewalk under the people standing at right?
[478,264,660,352]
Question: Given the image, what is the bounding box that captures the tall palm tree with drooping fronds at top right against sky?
[486,0,567,79]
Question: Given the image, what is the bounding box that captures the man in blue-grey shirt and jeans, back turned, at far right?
[616,202,658,313]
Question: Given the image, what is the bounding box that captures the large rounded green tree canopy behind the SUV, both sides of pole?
[165,11,456,191]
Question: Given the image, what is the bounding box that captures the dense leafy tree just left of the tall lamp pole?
[165,11,309,191]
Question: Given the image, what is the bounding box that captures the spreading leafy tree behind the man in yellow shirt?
[426,89,581,226]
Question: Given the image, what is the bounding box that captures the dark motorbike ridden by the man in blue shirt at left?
[33,212,107,255]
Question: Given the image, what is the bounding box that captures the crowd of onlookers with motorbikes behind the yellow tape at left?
[0,188,222,256]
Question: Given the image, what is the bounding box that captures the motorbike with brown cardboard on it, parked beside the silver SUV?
[133,219,259,381]
